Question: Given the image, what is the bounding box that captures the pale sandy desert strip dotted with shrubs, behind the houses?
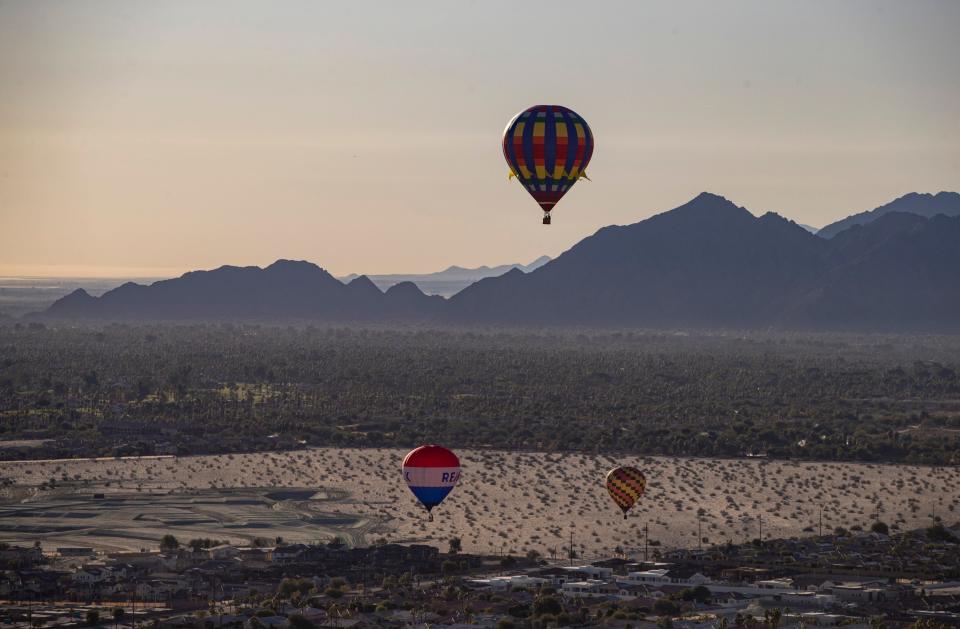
[0,449,960,557]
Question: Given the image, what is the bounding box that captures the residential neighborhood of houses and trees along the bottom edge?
[0,529,960,629]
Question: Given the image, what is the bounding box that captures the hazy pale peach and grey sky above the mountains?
[0,0,960,276]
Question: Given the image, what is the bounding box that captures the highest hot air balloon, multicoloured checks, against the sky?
[503,105,593,225]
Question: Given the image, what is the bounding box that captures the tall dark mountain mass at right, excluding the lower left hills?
[448,193,960,330]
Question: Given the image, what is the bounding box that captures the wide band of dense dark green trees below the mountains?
[0,324,960,463]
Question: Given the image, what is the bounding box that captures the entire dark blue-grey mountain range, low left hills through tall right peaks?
[42,192,960,331]
